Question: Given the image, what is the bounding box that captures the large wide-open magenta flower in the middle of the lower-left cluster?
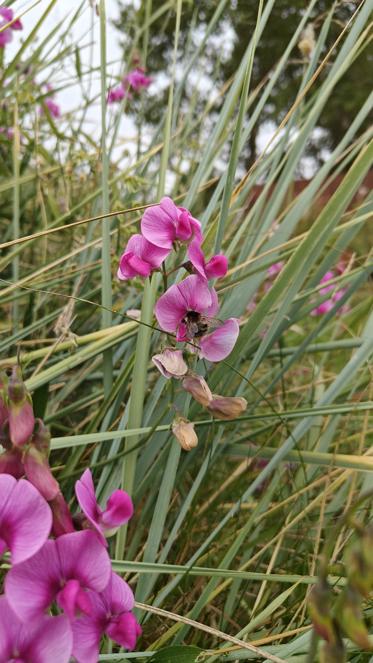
[5,531,111,622]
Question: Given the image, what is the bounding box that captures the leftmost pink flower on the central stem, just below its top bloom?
[117,235,170,281]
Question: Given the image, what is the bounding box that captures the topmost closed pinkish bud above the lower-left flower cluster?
[8,366,35,447]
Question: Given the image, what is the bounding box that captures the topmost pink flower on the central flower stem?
[141,196,202,250]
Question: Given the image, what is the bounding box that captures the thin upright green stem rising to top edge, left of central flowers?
[100,0,113,396]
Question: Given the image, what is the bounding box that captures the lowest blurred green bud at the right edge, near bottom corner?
[336,586,373,650]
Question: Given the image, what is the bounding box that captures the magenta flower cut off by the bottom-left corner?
[0,596,73,663]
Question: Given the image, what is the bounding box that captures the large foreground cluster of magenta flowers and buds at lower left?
[0,366,141,663]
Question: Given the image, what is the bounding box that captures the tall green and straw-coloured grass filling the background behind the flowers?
[0,0,373,663]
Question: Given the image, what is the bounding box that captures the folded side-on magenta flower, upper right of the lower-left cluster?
[75,469,133,544]
